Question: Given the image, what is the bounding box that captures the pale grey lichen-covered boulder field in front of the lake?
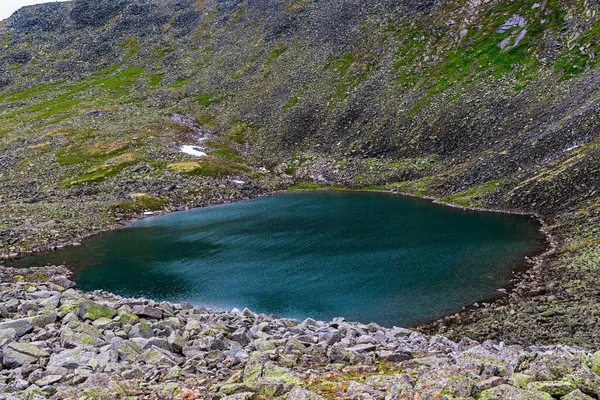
[0,267,600,400]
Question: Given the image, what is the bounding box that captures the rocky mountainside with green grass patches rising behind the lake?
[0,0,600,342]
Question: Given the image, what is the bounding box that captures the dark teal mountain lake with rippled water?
[12,192,544,326]
